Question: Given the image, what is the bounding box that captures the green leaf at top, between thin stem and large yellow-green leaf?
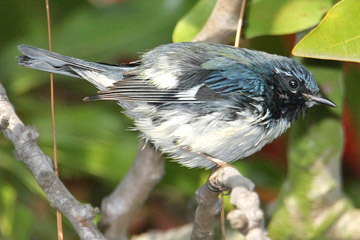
[244,0,333,38]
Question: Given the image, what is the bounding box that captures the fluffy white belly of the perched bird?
[134,104,290,168]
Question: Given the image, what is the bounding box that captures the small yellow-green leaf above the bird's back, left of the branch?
[173,0,216,42]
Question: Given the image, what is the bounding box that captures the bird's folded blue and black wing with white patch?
[85,54,260,103]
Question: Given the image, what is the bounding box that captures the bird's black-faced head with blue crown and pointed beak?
[255,56,336,121]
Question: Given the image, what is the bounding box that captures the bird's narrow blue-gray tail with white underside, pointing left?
[18,45,129,90]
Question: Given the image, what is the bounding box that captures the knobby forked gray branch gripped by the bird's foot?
[192,164,269,240]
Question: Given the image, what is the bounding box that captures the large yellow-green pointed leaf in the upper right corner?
[293,0,360,62]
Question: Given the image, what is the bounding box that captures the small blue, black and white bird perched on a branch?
[18,42,336,169]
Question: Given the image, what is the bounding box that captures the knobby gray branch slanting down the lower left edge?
[0,84,105,240]
